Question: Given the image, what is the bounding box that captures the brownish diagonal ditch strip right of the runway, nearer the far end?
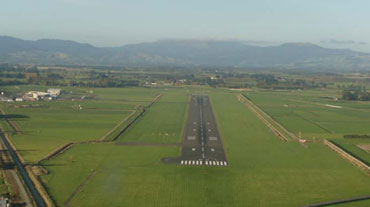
[237,94,289,142]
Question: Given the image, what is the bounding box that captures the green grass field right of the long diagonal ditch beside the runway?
[248,89,370,138]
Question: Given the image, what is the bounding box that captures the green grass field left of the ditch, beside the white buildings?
[1,86,160,162]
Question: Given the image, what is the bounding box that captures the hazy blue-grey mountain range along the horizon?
[0,36,370,70]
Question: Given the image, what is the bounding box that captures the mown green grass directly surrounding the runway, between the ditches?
[36,86,370,207]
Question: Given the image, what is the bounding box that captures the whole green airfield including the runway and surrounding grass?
[0,86,370,207]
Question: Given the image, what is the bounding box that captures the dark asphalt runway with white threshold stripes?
[180,95,228,166]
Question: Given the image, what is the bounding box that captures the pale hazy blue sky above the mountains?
[0,0,370,51]
